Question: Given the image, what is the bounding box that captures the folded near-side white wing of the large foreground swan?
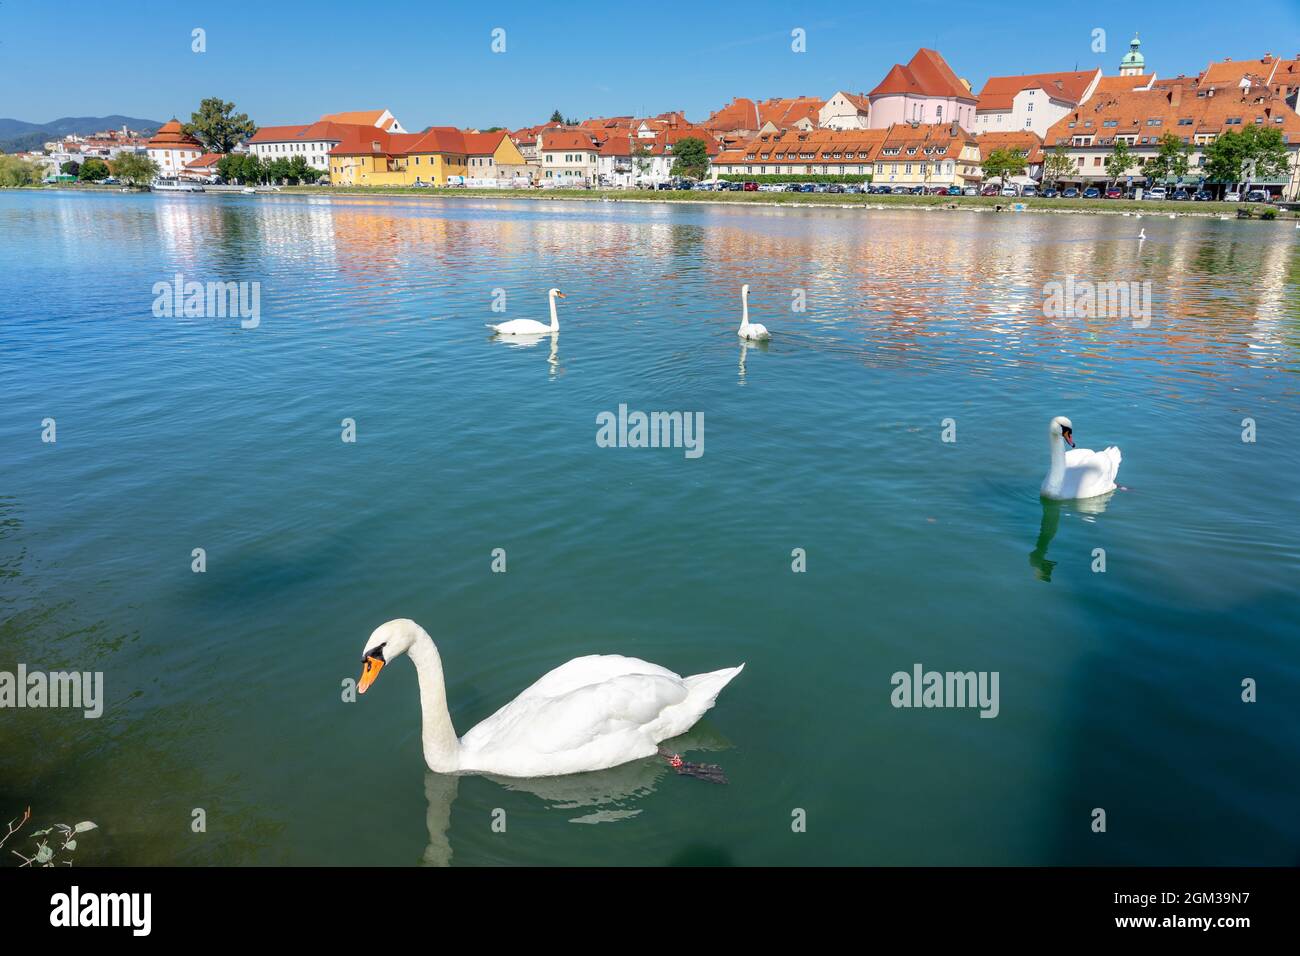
[460,674,689,775]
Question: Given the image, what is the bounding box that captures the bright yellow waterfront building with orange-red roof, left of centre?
[329,126,473,186]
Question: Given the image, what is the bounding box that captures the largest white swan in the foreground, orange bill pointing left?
[358,619,745,777]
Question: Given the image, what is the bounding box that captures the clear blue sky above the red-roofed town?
[0,0,1300,129]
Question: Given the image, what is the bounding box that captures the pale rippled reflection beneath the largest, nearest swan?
[421,723,731,866]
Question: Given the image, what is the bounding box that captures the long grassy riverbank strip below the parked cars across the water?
[271,186,1300,221]
